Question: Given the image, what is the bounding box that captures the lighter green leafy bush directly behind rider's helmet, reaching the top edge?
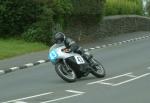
[22,0,72,45]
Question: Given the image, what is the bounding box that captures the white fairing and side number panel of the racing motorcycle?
[49,45,85,64]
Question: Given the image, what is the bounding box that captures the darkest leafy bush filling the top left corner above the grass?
[0,0,41,37]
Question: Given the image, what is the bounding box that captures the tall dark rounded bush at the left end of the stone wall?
[69,0,105,41]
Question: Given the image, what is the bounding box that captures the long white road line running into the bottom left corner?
[2,92,53,103]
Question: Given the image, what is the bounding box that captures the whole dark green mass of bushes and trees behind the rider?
[0,0,105,44]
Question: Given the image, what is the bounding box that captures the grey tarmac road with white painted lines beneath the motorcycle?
[0,32,150,103]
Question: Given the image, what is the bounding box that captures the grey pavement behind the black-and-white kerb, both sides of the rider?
[0,31,150,70]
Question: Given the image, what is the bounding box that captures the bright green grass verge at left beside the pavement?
[0,38,48,60]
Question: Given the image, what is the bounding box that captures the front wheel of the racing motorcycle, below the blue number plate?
[55,63,77,83]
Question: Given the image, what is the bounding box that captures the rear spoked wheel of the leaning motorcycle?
[91,58,105,78]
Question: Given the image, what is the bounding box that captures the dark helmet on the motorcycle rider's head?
[54,32,65,44]
